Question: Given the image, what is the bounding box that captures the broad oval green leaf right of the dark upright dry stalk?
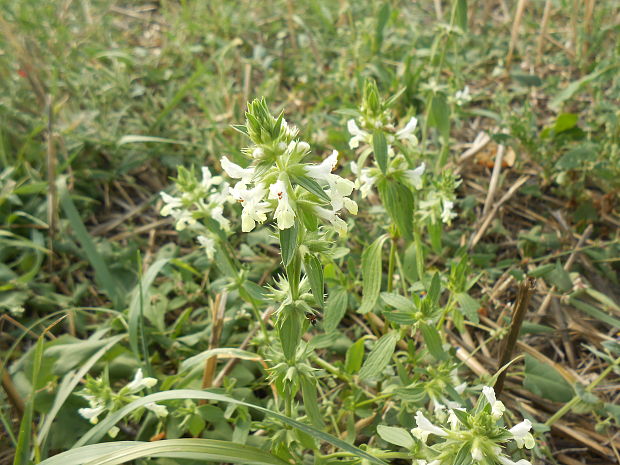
[523,355,575,402]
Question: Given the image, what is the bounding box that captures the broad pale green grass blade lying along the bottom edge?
[40,438,286,465]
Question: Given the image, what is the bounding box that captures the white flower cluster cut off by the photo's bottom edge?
[411,386,534,465]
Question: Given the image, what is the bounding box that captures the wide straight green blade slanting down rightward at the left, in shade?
[58,178,122,308]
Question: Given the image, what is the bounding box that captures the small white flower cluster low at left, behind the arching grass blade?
[78,369,168,437]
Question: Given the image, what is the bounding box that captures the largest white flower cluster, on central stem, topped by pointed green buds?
[221,100,357,234]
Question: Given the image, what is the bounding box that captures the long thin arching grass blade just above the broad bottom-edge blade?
[70,389,387,465]
